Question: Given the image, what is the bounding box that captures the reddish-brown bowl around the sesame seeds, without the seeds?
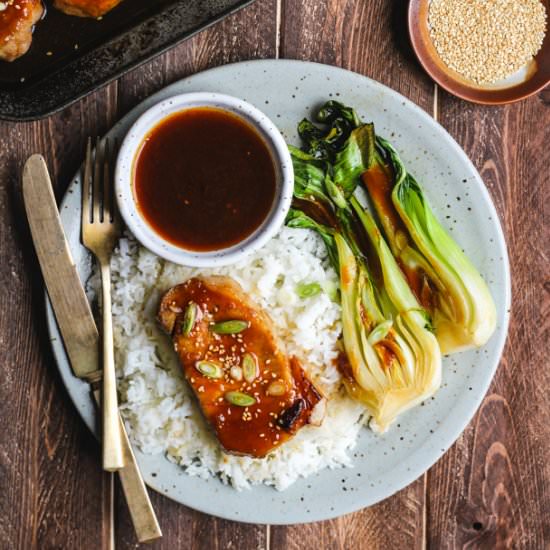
[409,0,550,105]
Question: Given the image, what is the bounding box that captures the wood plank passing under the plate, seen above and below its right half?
[271,0,433,550]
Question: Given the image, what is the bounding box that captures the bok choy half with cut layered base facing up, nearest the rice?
[287,149,441,432]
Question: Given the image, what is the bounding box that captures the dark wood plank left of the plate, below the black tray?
[0,86,120,549]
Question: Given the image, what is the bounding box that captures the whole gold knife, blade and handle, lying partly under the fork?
[23,155,162,542]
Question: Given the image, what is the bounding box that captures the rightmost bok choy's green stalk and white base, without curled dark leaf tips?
[362,137,496,353]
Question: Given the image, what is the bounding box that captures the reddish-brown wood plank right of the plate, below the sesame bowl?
[429,92,550,549]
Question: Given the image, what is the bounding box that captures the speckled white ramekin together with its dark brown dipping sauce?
[115,93,293,267]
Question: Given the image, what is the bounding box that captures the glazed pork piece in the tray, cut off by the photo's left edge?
[0,0,44,61]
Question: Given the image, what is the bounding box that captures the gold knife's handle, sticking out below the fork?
[94,390,162,542]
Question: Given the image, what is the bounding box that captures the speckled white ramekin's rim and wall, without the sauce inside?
[115,92,294,267]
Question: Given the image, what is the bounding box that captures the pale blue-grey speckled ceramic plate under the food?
[48,61,510,524]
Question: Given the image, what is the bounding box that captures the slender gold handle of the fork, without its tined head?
[100,258,124,472]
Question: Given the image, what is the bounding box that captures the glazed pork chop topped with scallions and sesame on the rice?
[158,276,325,457]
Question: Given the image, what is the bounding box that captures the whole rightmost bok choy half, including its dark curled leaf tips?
[301,102,496,354]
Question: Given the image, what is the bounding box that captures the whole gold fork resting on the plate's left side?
[82,138,124,472]
